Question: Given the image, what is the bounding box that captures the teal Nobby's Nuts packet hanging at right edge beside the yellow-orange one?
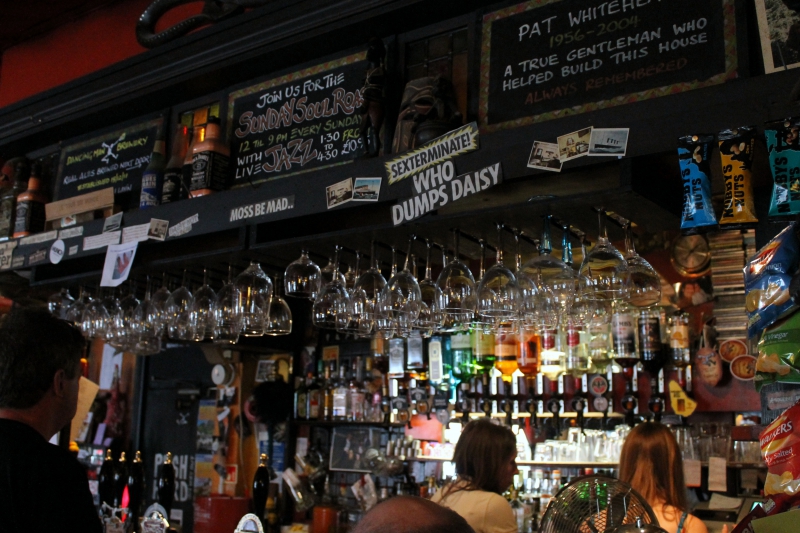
[764,117,800,217]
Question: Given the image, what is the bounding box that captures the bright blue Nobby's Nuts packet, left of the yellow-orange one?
[678,135,717,232]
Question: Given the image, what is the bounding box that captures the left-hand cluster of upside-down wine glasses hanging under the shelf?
[48,262,292,355]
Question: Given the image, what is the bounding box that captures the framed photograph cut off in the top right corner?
[756,0,800,74]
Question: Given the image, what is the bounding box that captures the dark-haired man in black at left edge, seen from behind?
[0,309,102,533]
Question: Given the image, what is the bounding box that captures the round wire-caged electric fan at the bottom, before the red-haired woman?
[539,476,666,533]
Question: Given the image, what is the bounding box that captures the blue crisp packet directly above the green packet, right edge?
[744,222,799,337]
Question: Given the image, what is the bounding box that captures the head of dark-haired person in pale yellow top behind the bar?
[453,419,518,494]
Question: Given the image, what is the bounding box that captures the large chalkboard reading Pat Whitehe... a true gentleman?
[480,0,737,131]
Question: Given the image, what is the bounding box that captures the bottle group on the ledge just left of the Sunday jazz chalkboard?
[139,110,230,209]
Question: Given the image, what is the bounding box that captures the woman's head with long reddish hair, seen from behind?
[619,422,687,511]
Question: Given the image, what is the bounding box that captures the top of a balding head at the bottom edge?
[353,496,475,533]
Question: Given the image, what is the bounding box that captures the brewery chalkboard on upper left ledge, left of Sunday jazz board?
[55,117,164,211]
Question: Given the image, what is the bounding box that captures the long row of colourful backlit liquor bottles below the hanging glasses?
[295,307,691,423]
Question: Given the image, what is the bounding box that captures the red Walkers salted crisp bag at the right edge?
[758,401,800,503]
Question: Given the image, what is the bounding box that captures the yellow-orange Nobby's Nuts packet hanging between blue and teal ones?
[718,126,758,225]
